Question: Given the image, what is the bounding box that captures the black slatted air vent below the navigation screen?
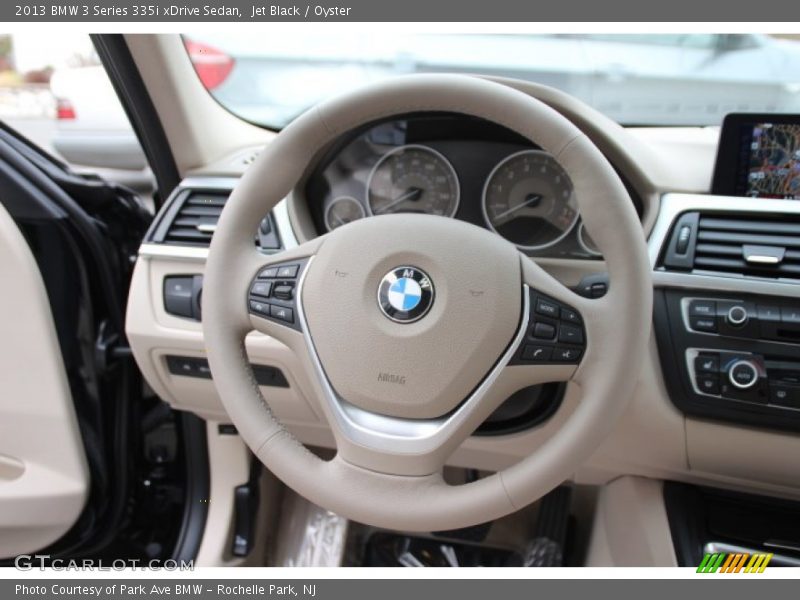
[663,212,800,282]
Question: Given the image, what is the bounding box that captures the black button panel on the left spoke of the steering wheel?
[247,260,307,330]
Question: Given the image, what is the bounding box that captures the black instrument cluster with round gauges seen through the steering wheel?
[303,114,641,259]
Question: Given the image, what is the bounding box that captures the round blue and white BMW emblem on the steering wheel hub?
[378,267,434,323]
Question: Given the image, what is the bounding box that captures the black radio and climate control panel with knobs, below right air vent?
[655,290,800,431]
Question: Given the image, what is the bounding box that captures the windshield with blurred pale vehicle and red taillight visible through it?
[184,32,800,129]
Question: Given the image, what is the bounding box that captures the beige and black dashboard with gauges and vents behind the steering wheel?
[127,76,800,516]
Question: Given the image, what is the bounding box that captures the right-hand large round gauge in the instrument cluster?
[483,150,578,250]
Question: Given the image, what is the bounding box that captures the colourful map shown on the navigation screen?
[747,123,800,200]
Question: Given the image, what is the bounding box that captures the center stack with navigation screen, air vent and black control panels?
[650,114,800,431]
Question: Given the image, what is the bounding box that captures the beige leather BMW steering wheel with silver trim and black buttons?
[203,75,652,531]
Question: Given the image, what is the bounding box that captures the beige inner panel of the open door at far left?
[0,206,89,558]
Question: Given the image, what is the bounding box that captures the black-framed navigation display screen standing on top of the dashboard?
[712,114,800,200]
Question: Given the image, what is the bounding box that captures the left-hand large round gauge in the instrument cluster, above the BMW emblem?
[367,145,459,217]
